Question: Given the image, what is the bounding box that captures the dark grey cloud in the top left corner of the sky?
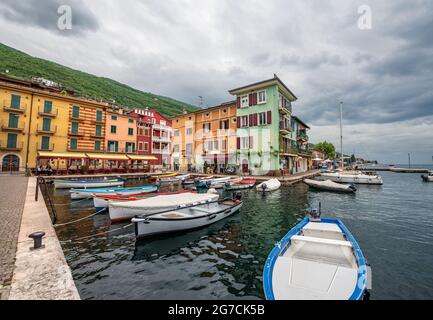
[0,0,99,35]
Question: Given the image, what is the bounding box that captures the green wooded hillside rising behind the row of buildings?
[0,43,198,116]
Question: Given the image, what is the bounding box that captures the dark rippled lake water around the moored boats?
[54,172,433,299]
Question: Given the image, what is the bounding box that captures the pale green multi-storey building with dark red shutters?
[229,75,297,175]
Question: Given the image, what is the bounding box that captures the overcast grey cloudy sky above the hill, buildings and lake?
[0,0,433,164]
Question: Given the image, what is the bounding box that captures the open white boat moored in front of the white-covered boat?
[132,195,242,238]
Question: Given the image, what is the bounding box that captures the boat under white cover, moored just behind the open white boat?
[108,192,219,221]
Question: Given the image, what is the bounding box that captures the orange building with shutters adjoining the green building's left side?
[172,101,237,173]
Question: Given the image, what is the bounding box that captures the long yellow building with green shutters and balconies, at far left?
[0,76,108,171]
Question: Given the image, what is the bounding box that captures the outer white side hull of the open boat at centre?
[132,203,242,238]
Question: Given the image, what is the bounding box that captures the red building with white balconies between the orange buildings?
[129,109,173,168]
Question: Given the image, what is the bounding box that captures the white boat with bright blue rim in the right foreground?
[263,210,367,300]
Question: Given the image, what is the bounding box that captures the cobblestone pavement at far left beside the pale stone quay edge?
[0,175,28,300]
